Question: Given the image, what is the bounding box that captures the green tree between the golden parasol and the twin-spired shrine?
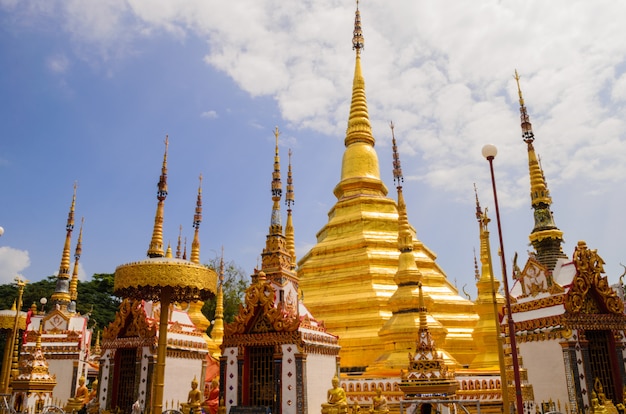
[202,257,250,332]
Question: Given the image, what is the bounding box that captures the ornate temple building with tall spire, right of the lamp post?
[511,73,626,412]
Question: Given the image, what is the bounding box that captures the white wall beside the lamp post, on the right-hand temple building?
[519,340,569,404]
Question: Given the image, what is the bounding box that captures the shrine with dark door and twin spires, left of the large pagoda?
[220,128,339,414]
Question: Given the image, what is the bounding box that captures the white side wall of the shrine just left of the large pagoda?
[305,354,337,413]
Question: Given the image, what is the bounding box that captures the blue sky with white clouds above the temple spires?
[0,0,626,300]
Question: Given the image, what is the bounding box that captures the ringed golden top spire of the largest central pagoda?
[334,2,387,198]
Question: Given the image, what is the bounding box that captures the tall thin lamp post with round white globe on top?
[482,144,524,414]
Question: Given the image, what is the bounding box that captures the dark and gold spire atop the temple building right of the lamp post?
[514,70,567,270]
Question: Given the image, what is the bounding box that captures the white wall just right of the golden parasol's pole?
[163,356,203,409]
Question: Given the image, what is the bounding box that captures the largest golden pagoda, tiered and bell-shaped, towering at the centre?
[298,2,478,372]
